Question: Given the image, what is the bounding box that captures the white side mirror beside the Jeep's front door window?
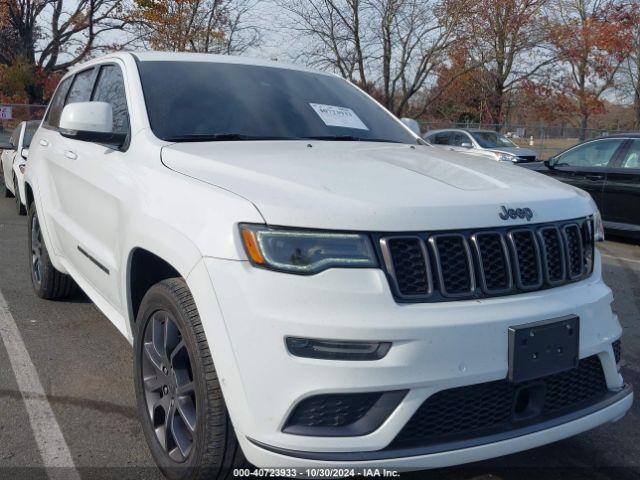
[60,102,127,147]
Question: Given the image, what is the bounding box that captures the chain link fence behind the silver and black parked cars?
[420,121,636,160]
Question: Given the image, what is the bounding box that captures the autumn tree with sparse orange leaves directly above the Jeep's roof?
[131,0,260,54]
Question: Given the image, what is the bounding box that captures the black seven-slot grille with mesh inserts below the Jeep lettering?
[380,218,593,302]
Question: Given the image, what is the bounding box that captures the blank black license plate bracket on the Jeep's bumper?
[509,315,580,383]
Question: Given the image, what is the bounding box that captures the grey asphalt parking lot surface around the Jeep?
[0,192,640,480]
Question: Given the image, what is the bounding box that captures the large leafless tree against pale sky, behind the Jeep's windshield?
[278,0,470,115]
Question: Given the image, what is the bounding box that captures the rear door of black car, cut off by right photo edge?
[602,139,640,232]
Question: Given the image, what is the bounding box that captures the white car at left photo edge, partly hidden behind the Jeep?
[0,120,40,215]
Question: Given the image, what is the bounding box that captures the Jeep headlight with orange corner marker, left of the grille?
[240,224,378,275]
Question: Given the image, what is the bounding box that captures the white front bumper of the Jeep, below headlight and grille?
[189,249,631,468]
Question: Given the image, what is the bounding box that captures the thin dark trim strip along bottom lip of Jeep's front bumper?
[247,384,633,462]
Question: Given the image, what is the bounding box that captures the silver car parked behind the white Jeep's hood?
[424,128,538,163]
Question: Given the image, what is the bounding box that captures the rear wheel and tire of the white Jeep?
[28,202,77,300]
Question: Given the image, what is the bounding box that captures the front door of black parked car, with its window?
[545,138,625,214]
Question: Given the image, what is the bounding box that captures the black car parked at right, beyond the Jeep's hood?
[524,133,640,238]
